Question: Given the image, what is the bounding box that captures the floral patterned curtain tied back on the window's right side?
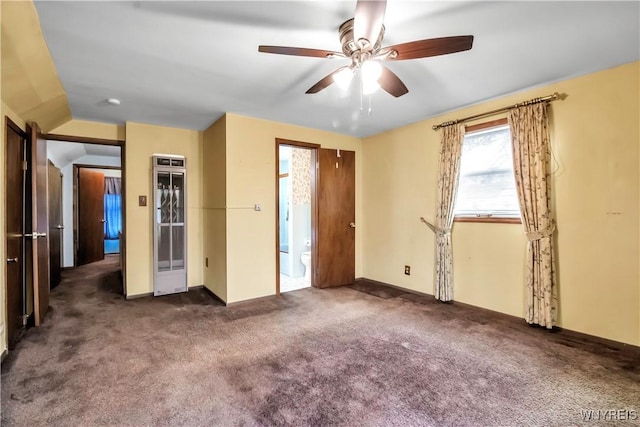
[508,103,557,329]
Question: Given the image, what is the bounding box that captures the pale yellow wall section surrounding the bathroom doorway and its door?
[226,114,363,302]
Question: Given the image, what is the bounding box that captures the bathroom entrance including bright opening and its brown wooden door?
[276,139,356,294]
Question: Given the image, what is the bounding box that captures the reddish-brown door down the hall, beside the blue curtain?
[76,168,104,265]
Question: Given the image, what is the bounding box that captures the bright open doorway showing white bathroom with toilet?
[276,139,319,294]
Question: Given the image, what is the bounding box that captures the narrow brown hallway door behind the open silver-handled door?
[48,162,64,289]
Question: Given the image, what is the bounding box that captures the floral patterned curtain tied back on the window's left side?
[433,124,464,302]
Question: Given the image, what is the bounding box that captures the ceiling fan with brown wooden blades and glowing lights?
[258,0,473,97]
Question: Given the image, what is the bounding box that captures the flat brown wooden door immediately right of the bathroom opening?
[314,148,356,288]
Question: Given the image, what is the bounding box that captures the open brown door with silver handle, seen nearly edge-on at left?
[31,123,49,326]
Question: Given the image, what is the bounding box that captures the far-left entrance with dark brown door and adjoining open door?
[4,118,49,348]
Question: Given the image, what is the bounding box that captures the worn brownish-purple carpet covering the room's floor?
[2,259,640,426]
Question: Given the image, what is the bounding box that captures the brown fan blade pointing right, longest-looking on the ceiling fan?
[380,36,473,61]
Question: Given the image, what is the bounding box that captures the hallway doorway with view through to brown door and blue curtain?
[45,134,126,296]
